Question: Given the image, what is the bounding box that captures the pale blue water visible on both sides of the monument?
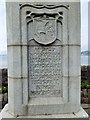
[0,55,90,68]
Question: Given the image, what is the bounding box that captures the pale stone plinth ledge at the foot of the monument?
[0,104,89,120]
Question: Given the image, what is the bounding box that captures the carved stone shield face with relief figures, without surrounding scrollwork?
[34,18,56,45]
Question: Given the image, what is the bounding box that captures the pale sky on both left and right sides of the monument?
[0,0,89,54]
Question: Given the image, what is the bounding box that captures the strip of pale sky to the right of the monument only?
[81,0,88,50]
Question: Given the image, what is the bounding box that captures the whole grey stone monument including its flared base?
[0,0,88,120]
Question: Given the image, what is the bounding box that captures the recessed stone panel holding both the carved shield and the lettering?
[27,13,63,97]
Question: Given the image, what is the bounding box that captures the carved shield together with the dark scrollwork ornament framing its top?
[26,11,63,45]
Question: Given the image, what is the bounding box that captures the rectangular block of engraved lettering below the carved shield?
[29,45,62,97]
